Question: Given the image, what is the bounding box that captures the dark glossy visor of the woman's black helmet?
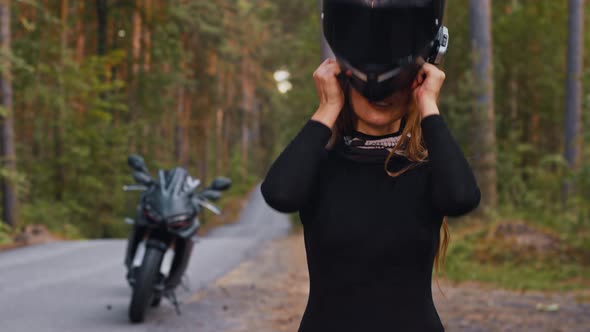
[324,1,440,65]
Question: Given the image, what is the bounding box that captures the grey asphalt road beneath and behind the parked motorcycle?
[0,189,290,332]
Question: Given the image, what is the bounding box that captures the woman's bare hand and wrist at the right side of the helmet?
[412,63,446,118]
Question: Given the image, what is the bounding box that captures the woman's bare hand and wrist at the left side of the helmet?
[312,59,344,128]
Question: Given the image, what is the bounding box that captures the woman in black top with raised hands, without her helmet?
[262,1,480,332]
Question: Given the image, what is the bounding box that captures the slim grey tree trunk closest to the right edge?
[563,0,584,202]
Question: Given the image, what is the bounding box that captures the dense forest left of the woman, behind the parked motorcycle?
[2,0,317,238]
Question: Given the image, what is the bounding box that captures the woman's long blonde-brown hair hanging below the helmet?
[329,85,451,297]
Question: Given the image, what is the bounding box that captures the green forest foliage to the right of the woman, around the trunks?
[441,0,590,223]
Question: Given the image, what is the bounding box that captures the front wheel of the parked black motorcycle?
[129,248,164,323]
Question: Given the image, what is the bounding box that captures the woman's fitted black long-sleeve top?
[261,115,480,332]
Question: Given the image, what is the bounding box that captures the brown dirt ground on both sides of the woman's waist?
[190,234,590,332]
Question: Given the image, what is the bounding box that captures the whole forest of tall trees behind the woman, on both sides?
[0,0,590,290]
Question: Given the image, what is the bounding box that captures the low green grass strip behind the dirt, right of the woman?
[441,221,590,291]
